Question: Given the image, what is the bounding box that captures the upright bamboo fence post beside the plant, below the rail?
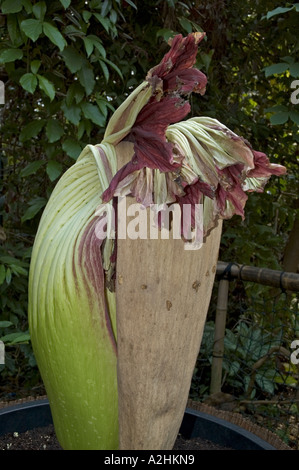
[210,279,229,395]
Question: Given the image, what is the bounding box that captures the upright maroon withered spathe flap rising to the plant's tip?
[102,33,207,202]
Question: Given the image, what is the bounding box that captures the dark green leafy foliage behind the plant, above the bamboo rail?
[0,0,299,396]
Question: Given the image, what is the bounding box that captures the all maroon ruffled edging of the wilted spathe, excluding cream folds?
[103,33,286,239]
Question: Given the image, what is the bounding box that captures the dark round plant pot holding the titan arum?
[0,399,276,450]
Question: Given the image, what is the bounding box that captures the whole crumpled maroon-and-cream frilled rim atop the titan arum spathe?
[103,33,286,239]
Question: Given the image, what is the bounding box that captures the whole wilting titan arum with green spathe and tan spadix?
[29,33,285,450]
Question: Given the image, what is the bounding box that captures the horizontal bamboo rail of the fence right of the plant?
[217,261,299,291]
